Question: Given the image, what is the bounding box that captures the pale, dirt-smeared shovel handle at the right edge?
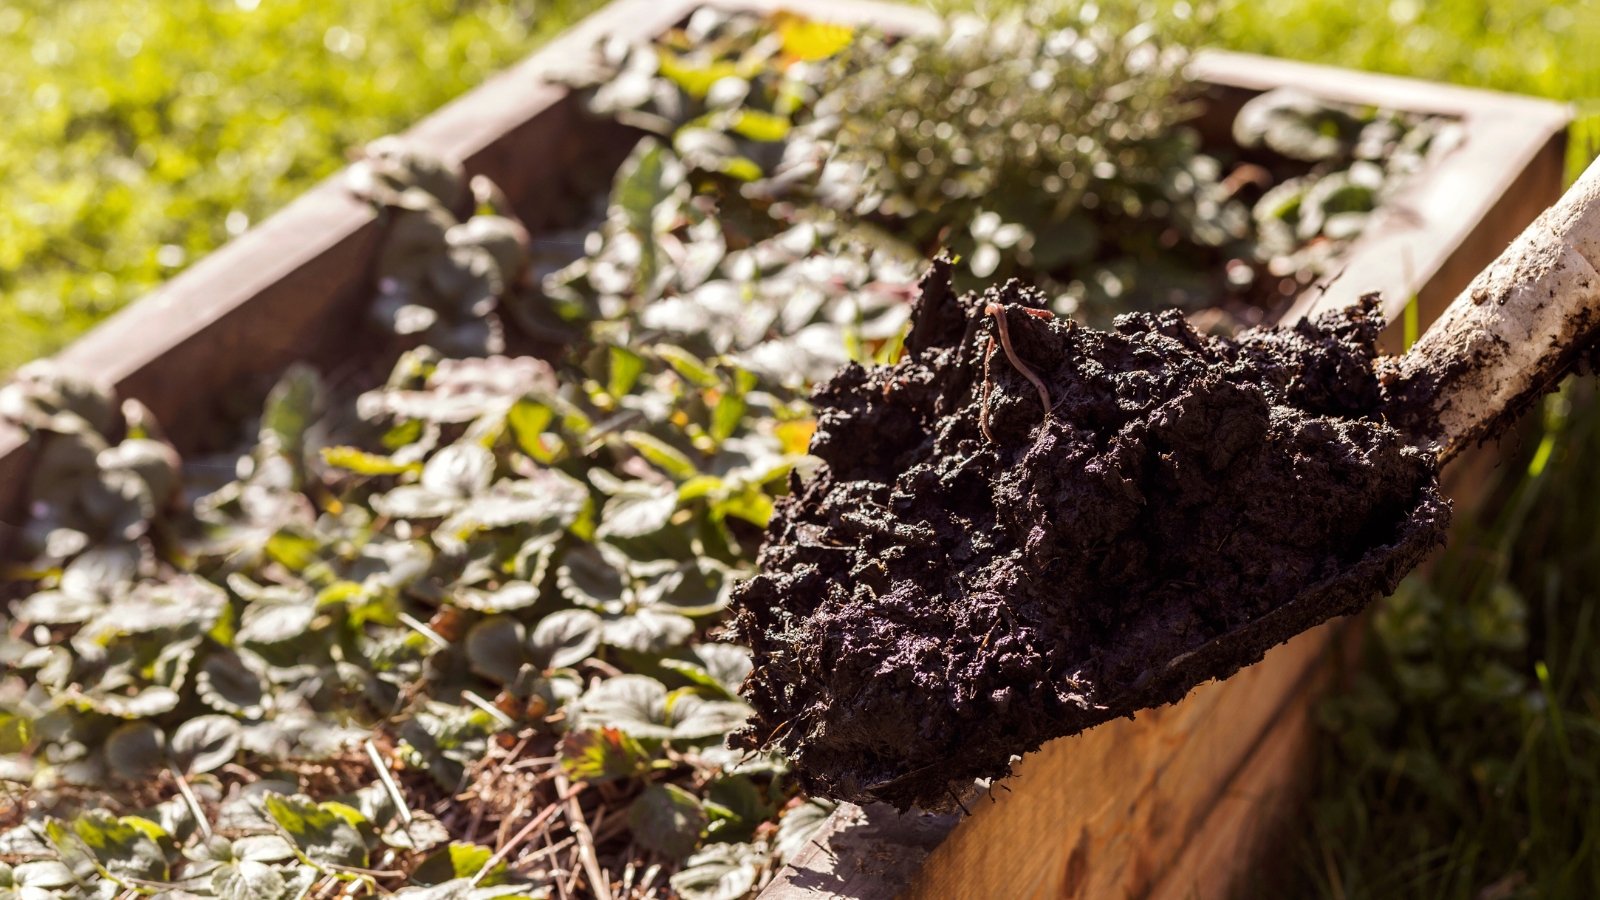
[1382,160,1600,464]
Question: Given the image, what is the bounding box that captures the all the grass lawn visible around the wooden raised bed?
[9,0,1600,900]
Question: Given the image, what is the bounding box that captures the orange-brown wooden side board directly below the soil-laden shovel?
[902,626,1333,900]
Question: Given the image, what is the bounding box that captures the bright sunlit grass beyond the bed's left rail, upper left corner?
[0,0,598,372]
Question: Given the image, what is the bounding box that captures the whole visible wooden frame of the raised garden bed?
[0,0,1568,898]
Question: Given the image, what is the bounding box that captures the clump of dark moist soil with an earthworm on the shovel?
[734,257,1450,809]
